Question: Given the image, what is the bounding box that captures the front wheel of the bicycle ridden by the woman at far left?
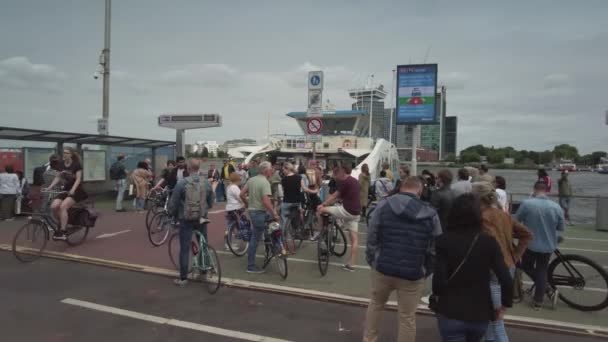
[13,221,49,262]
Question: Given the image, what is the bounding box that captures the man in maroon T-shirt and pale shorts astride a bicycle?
[312,164,361,272]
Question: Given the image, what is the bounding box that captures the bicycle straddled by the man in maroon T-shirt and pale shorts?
[317,213,348,276]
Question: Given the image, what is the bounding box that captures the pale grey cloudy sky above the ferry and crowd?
[0,0,608,153]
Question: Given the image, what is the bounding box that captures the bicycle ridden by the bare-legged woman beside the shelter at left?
[12,191,97,262]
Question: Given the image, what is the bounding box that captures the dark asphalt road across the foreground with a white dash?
[0,252,601,342]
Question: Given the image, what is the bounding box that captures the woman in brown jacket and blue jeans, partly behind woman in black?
[473,182,532,342]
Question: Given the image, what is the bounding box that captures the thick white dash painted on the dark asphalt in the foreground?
[61,298,290,342]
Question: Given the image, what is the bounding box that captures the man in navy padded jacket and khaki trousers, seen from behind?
[363,177,442,342]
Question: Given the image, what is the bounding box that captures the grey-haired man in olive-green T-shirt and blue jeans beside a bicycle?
[240,162,281,274]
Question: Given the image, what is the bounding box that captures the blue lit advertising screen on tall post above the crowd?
[395,64,437,125]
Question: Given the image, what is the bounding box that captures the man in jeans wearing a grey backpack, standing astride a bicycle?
[169,159,213,287]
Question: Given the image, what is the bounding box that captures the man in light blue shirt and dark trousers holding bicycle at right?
[515,181,565,311]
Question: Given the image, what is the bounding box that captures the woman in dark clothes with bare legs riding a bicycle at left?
[48,147,88,240]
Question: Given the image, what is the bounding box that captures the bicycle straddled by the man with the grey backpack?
[169,220,222,294]
